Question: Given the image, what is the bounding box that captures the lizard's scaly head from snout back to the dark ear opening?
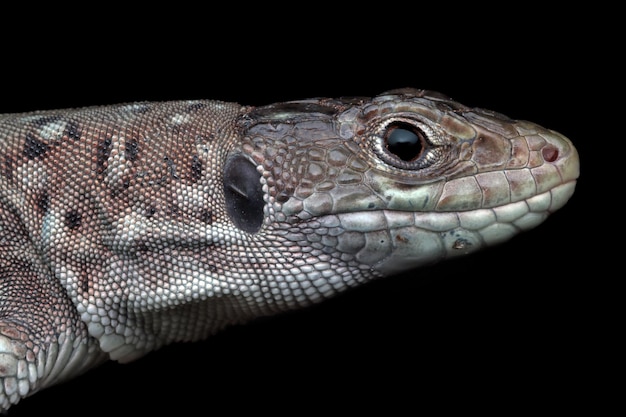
[224,89,579,282]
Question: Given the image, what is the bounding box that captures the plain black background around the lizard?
[0,4,608,416]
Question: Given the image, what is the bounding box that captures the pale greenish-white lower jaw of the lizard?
[337,180,576,275]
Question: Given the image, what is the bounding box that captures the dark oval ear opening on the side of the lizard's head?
[224,155,265,233]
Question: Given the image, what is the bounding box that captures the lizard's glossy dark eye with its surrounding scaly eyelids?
[373,117,439,170]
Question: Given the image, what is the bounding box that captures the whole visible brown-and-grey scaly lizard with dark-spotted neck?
[0,88,579,411]
